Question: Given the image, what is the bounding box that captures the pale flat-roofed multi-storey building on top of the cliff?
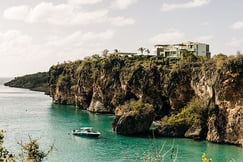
[154,42,211,58]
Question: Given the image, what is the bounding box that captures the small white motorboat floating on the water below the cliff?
[72,127,101,137]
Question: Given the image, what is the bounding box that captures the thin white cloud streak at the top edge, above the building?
[161,0,210,11]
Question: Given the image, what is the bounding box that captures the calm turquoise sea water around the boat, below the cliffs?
[0,79,243,162]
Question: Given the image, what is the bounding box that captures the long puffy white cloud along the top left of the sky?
[3,0,135,26]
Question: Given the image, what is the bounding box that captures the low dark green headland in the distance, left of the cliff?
[4,72,49,94]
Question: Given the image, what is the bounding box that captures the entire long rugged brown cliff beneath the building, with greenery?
[49,56,243,145]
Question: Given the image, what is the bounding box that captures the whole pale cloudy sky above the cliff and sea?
[0,0,243,77]
